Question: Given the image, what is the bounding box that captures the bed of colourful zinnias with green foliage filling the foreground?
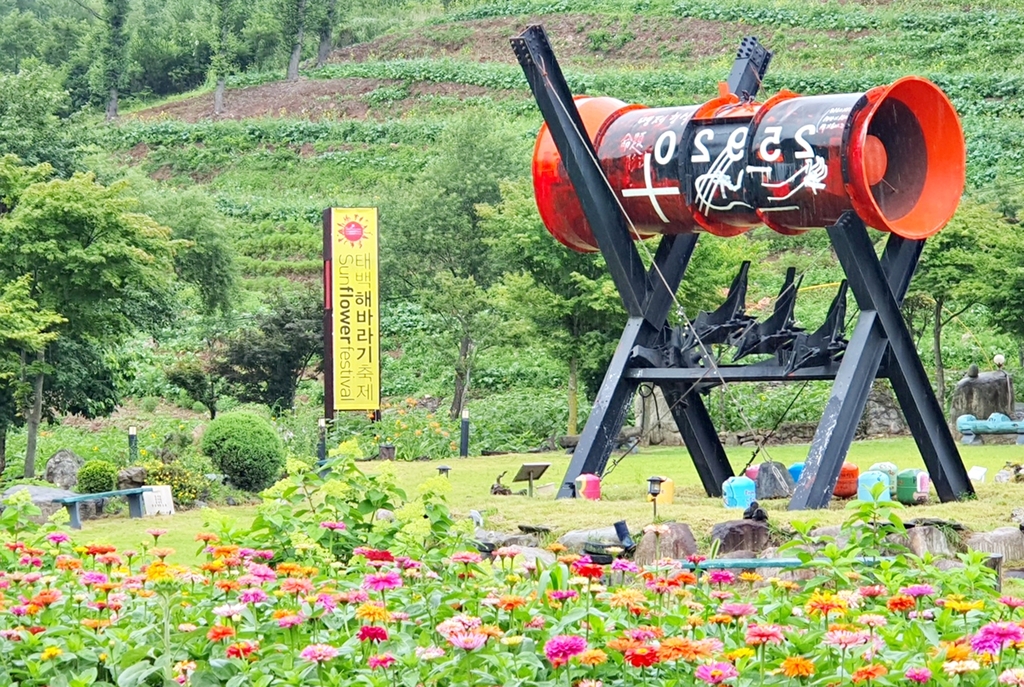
[0,456,1011,687]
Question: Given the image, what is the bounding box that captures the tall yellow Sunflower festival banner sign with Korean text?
[324,208,381,417]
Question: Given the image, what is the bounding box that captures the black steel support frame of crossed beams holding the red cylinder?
[511,27,973,510]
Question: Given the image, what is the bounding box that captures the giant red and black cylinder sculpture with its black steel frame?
[511,27,974,509]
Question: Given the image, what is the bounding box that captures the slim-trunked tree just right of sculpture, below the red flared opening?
[912,202,1006,399]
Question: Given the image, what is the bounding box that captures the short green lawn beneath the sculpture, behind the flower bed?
[80,438,1024,563]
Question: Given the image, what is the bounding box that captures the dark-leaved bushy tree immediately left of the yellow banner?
[216,291,324,410]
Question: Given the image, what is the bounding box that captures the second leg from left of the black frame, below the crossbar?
[662,383,735,497]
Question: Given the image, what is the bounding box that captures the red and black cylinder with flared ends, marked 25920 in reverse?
[534,77,966,251]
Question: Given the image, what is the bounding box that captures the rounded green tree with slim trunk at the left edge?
[0,156,174,477]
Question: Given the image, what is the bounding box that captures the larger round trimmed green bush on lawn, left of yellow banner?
[203,412,285,491]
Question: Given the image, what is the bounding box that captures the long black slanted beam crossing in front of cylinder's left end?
[511,26,647,319]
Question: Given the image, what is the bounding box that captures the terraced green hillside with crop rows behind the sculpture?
[77,0,1024,440]
